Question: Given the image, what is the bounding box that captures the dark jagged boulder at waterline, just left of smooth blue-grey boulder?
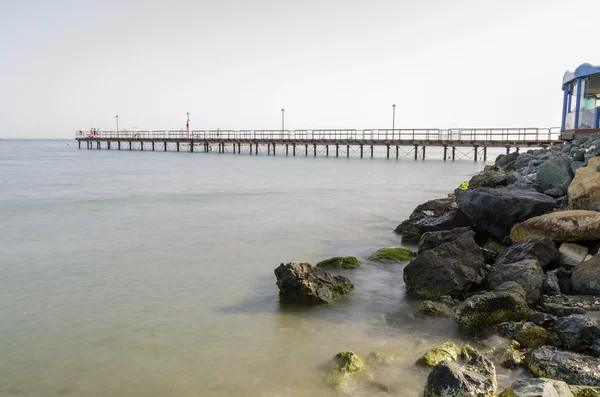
[394,198,469,242]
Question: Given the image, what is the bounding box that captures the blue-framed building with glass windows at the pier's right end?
[561,63,600,139]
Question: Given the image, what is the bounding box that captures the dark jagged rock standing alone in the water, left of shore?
[275,263,354,305]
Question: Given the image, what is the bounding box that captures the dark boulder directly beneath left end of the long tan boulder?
[496,237,559,269]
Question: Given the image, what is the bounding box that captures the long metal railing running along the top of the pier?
[75,127,560,142]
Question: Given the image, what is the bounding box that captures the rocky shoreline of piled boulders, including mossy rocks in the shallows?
[275,135,600,397]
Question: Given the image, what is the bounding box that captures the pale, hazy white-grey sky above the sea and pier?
[0,0,600,138]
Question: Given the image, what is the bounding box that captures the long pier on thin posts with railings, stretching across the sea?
[75,128,562,161]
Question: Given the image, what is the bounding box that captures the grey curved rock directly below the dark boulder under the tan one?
[487,259,544,303]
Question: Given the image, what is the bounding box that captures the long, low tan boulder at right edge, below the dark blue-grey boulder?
[510,210,600,242]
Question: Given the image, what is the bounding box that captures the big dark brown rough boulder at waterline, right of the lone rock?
[404,231,484,299]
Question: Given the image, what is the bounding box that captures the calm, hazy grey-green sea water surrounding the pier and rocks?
[0,140,516,397]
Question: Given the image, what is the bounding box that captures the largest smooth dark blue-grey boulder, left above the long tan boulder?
[456,187,556,241]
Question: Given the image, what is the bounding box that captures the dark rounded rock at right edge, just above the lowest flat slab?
[554,314,600,351]
